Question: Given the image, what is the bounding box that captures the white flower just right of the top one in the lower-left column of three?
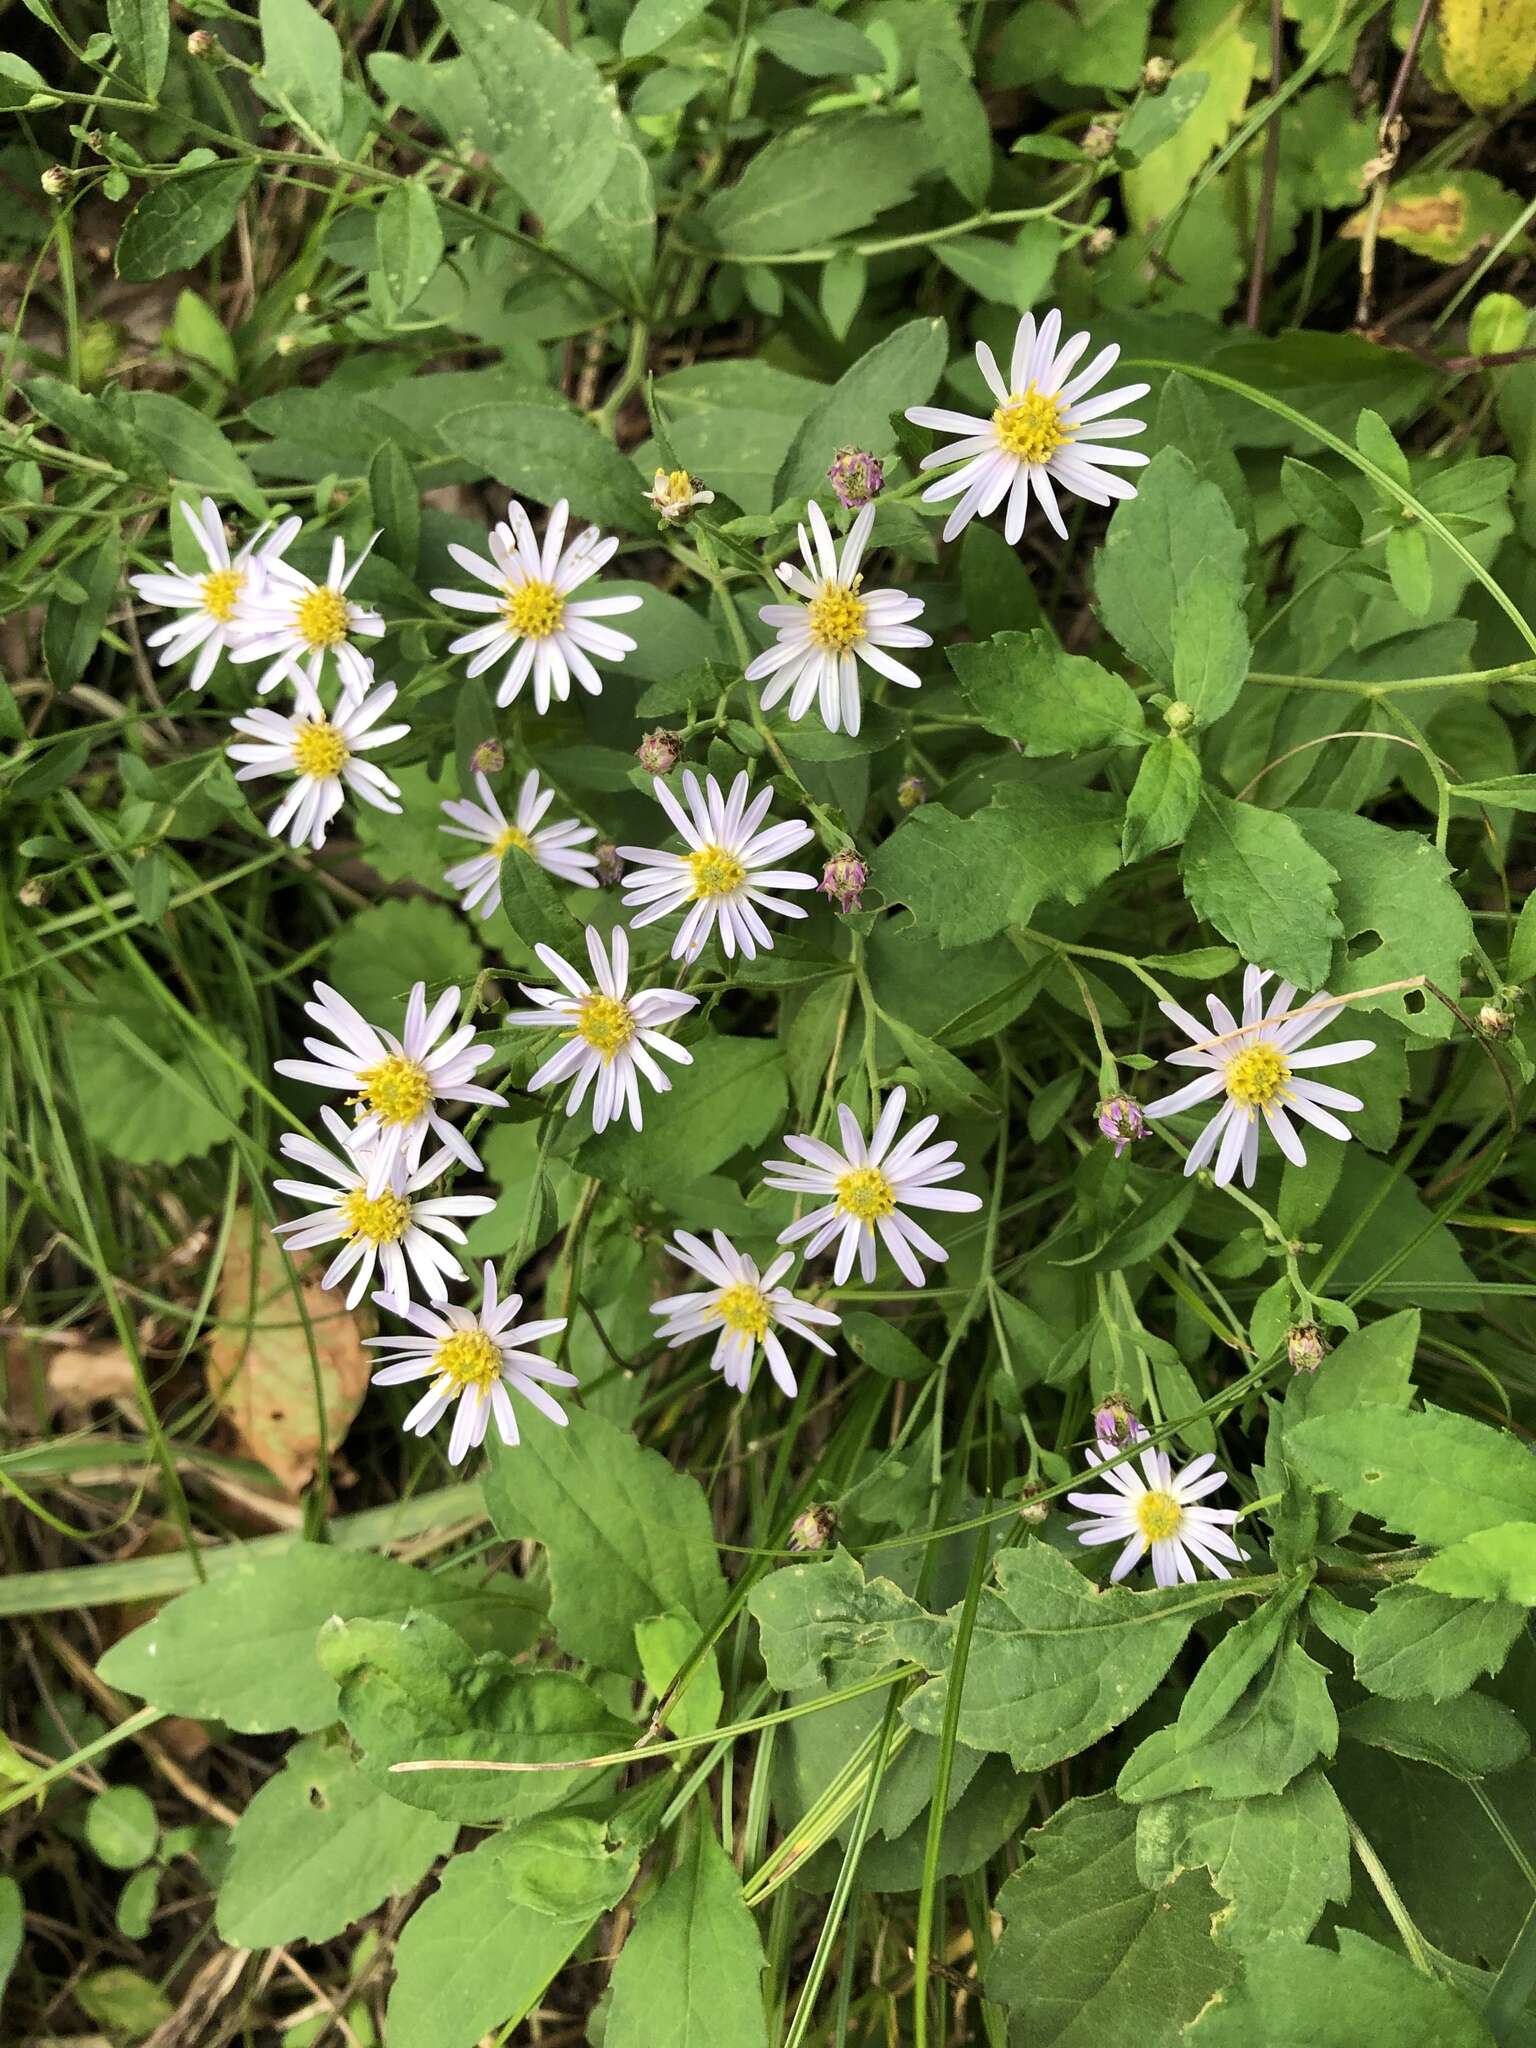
[506,928,698,1130]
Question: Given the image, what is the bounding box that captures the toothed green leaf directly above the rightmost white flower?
[1184,788,1343,989]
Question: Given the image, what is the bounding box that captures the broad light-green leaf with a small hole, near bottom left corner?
[219,1736,459,1948]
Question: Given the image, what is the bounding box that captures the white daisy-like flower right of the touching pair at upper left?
[432,498,641,717]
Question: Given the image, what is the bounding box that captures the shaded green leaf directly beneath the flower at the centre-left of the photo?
[578,1032,788,1196]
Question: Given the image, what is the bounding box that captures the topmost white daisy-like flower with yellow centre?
[907,311,1151,547]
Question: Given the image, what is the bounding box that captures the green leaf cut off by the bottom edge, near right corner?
[1186,1927,1493,2048]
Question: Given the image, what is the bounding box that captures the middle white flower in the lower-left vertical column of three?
[272,1104,496,1309]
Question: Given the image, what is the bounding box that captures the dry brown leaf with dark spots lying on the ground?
[207,1210,369,1493]
